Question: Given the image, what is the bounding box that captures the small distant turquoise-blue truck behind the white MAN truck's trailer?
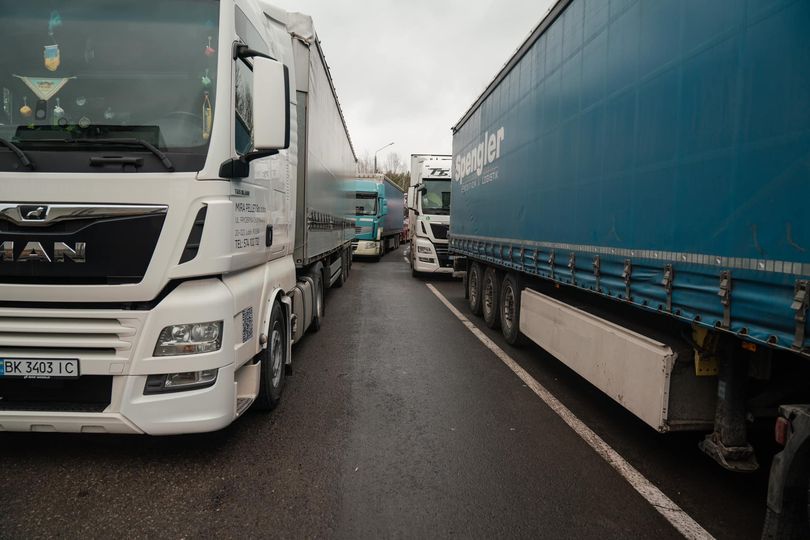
[346,174,405,260]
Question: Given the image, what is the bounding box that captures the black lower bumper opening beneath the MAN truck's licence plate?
[0,375,112,412]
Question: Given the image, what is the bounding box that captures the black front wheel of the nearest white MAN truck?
[253,302,288,411]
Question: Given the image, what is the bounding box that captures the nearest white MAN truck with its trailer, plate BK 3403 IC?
[0,0,356,435]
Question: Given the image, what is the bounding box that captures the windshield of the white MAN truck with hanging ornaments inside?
[0,0,219,153]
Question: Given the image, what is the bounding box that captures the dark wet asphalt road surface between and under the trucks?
[0,251,767,540]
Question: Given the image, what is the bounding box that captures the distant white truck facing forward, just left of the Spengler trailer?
[407,154,453,276]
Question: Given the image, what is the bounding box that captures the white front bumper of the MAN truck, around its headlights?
[0,279,241,435]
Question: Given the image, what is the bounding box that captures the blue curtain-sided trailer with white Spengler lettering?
[450,0,810,538]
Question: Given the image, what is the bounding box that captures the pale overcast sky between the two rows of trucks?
[273,0,554,169]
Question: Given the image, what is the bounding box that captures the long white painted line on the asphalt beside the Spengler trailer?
[426,283,714,540]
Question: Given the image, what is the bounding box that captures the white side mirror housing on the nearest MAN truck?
[253,56,290,152]
